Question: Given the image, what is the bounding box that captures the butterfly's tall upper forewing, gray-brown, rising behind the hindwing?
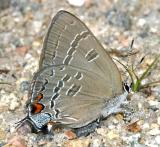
[39,11,122,97]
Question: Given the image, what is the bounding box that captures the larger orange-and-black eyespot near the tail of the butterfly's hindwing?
[30,103,44,114]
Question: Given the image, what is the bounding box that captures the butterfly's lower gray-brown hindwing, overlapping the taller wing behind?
[31,65,107,127]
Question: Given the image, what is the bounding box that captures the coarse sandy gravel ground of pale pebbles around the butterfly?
[0,0,160,147]
